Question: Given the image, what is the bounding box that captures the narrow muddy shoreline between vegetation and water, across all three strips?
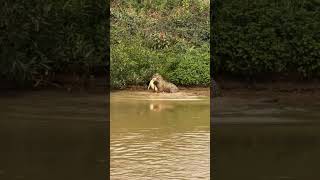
[0,78,320,102]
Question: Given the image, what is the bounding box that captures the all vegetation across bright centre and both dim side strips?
[0,0,320,88]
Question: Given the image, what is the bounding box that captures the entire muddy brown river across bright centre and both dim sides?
[0,91,320,180]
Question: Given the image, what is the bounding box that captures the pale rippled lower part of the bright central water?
[110,129,210,179]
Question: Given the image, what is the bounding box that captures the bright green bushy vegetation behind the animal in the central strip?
[110,0,210,88]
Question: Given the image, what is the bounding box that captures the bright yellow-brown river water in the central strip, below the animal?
[110,93,210,180]
